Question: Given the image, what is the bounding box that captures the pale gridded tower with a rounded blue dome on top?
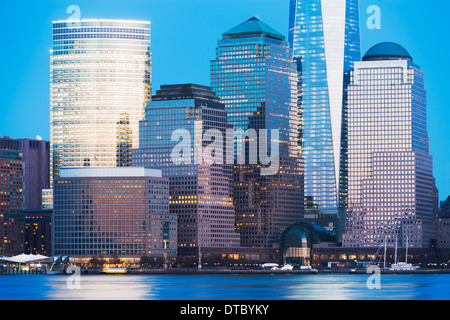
[342,43,437,248]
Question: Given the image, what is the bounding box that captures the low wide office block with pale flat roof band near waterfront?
[52,167,177,261]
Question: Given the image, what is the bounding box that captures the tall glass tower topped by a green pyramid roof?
[211,17,303,248]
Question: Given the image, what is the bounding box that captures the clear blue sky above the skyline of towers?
[0,0,450,200]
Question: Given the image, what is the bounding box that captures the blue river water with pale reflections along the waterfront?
[0,274,450,300]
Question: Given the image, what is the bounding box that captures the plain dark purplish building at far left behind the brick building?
[0,137,50,210]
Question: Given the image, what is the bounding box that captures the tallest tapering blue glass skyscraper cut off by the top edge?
[289,0,361,234]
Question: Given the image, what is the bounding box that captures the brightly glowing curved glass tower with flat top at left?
[50,20,151,177]
